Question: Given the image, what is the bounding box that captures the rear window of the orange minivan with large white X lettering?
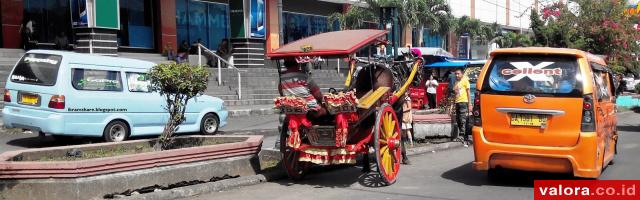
[482,55,582,97]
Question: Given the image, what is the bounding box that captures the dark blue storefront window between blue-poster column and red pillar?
[118,0,154,49]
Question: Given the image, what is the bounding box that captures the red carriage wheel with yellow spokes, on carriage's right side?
[373,104,401,185]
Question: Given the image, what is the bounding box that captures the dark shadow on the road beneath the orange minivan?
[441,163,581,187]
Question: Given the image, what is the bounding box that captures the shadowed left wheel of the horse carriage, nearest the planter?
[280,118,309,181]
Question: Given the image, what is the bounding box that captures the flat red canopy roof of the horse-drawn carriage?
[267,29,388,59]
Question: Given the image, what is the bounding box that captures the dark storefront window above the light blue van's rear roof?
[23,0,73,45]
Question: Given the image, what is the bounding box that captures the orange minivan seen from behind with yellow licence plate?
[472,47,617,178]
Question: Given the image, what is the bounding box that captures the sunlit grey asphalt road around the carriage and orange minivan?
[184,113,640,200]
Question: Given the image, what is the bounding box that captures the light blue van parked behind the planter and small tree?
[2,50,227,142]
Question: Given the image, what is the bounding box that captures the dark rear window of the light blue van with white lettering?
[10,53,62,86]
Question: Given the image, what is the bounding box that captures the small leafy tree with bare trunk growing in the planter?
[149,63,209,150]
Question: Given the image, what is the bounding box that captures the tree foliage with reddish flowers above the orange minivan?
[531,0,640,73]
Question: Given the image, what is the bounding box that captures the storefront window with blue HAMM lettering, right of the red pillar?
[176,0,229,49]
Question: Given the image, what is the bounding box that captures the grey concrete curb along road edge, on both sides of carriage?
[117,142,463,200]
